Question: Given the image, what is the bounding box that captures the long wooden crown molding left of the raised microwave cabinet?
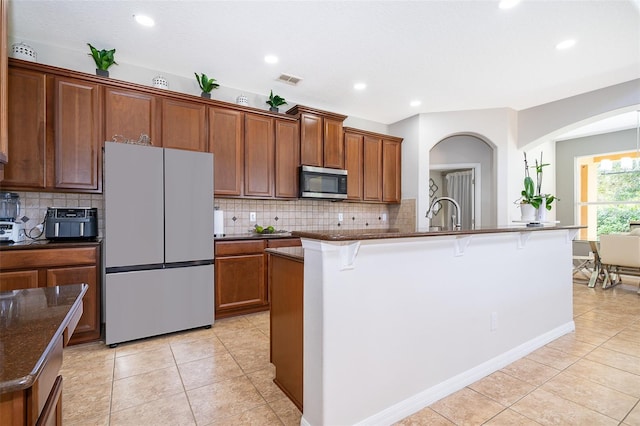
[9,58,298,121]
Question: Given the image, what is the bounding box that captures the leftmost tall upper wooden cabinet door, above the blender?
[3,68,47,190]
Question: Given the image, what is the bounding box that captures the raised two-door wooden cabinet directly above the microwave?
[287,105,347,169]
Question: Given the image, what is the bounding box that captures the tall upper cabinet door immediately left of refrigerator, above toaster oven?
[54,77,104,190]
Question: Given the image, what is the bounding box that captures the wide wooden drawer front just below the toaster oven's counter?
[0,247,97,270]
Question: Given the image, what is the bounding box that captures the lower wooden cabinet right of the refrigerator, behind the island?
[215,238,300,318]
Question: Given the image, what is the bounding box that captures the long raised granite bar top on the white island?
[291,225,586,241]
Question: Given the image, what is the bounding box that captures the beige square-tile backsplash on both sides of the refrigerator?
[18,192,416,237]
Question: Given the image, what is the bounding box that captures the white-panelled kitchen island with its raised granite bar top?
[293,226,581,426]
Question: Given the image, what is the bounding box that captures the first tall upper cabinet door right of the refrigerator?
[209,107,244,196]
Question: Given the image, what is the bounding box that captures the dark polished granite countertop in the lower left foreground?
[0,284,88,394]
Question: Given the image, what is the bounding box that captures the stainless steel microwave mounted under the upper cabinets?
[300,166,347,200]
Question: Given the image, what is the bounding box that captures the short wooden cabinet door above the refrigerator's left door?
[104,87,161,146]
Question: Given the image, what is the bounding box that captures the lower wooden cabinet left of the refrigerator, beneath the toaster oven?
[0,243,101,345]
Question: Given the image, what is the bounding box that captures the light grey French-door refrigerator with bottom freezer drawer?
[104,142,214,346]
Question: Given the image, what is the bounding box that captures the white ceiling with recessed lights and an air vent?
[9,0,640,124]
